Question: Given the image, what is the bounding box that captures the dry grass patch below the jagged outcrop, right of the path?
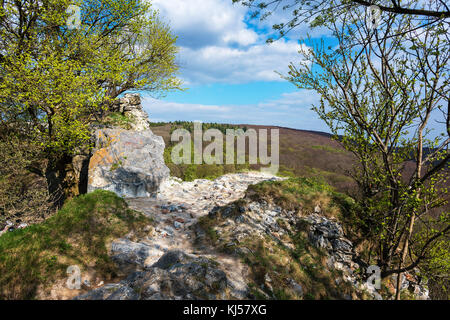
[240,231,354,300]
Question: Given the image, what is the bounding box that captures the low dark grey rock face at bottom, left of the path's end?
[75,250,227,300]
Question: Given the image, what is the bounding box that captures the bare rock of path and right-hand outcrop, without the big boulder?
[77,172,428,299]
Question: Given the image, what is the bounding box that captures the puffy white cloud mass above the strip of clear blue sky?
[152,0,310,85]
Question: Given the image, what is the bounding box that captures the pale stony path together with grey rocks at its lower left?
[77,172,282,299]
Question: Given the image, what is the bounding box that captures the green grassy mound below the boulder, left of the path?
[0,190,151,299]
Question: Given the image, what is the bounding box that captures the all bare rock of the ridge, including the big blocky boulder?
[76,95,428,300]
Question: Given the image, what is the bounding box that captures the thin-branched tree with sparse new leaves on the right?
[234,1,450,299]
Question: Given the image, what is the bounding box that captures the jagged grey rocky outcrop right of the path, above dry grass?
[200,198,429,300]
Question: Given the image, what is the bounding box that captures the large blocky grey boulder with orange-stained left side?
[88,129,170,198]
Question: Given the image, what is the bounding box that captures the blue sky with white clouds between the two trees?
[144,0,327,131]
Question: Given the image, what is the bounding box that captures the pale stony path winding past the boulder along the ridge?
[100,172,282,299]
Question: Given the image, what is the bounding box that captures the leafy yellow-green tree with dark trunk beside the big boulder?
[0,0,180,203]
